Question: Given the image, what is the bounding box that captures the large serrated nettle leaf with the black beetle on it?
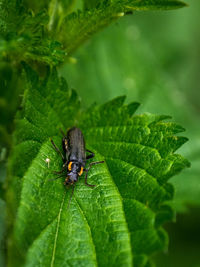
[7,66,189,266]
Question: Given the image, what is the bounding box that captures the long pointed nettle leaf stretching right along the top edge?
[58,0,186,54]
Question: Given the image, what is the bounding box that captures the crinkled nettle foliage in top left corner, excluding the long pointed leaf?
[0,0,65,65]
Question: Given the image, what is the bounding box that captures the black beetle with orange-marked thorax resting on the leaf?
[51,127,104,207]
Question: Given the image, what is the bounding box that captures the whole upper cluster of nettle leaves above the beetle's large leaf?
[0,0,185,65]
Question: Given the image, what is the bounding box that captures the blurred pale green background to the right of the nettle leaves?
[60,0,200,267]
